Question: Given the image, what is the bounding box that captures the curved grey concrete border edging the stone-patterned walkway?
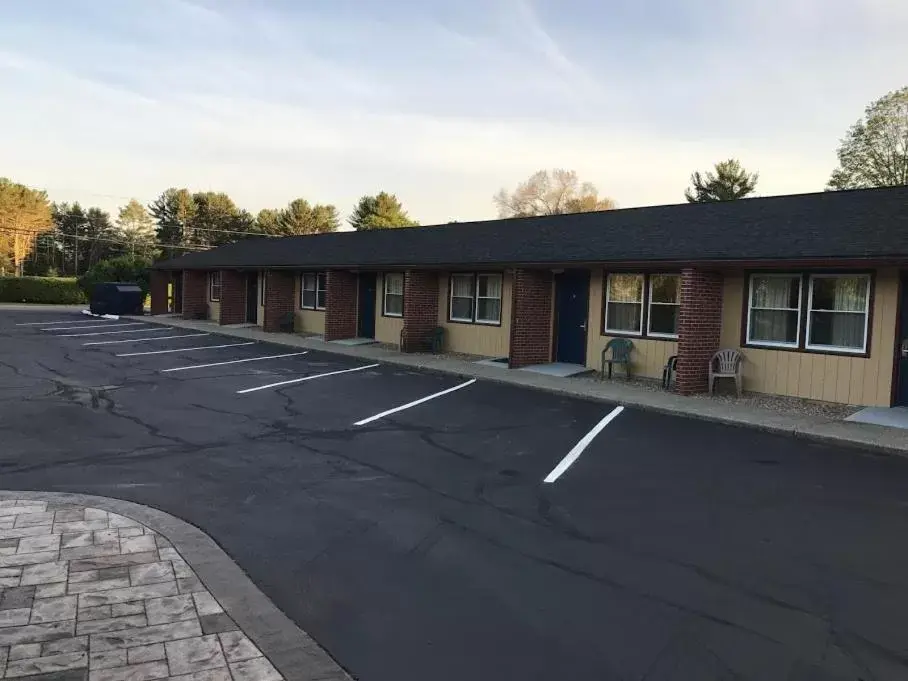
[0,490,351,681]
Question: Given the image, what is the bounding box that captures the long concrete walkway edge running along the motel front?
[131,316,908,456]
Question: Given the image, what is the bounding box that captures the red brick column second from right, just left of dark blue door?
[508,270,554,369]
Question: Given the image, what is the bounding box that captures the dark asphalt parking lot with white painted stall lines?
[0,310,908,681]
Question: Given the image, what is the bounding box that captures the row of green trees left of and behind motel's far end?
[0,186,417,276]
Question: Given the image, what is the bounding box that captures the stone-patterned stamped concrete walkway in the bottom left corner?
[0,492,348,681]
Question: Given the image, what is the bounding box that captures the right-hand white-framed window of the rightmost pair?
[806,274,870,353]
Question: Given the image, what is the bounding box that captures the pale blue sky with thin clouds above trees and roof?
[0,0,908,224]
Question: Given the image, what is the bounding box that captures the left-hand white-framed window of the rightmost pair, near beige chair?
[747,274,803,348]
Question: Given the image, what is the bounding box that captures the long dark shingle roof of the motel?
[156,186,908,269]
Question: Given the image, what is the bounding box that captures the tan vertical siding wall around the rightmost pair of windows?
[722,269,899,407]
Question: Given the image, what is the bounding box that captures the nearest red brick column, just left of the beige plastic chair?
[675,268,722,395]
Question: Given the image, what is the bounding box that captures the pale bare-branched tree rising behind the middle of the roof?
[493,168,617,218]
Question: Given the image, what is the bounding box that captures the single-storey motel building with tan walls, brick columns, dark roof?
[151,187,908,407]
